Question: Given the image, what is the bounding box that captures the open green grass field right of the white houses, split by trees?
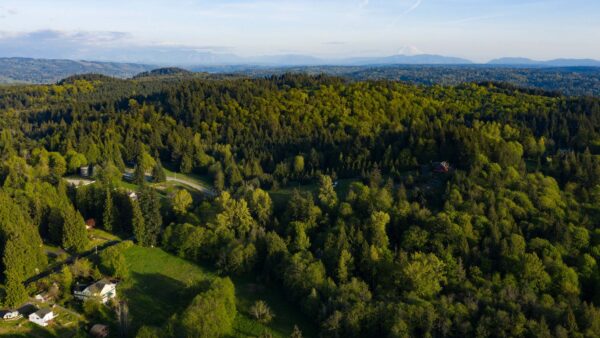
[122,246,316,338]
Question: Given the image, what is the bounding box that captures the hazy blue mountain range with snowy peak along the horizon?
[0,52,600,83]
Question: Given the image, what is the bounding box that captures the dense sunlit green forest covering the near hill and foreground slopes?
[0,74,600,337]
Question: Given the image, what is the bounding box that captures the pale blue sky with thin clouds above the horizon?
[0,0,600,61]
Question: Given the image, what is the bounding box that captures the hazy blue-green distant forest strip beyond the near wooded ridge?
[219,65,600,96]
